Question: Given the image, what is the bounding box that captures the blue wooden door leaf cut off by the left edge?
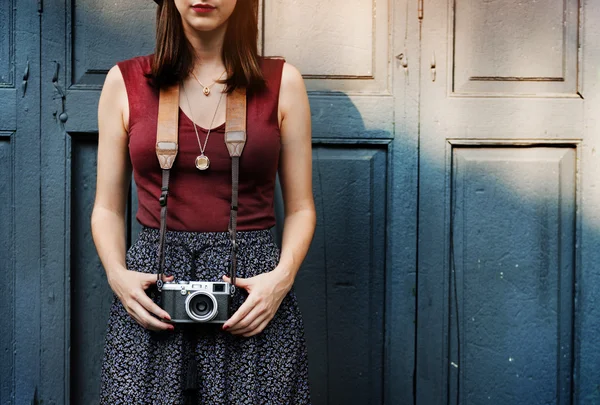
[0,0,42,404]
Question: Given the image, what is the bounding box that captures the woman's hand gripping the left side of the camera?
[108,269,175,331]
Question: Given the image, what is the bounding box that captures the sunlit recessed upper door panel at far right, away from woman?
[452,0,579,96]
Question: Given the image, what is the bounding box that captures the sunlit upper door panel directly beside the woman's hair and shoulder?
[263,0,390,94]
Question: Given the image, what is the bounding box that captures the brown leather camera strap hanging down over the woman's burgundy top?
[156,84,246,291]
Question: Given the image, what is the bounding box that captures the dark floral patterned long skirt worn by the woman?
[100,228,310,405]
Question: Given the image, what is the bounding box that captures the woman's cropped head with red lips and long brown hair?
[151,0,264,92]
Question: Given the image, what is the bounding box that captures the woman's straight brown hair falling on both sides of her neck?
[148,0,265,92]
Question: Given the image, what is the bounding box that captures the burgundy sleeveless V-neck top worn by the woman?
[118,55,284,232]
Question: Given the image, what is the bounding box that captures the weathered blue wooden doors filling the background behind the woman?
[9,0,600,405]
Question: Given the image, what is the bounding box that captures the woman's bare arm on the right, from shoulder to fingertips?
[223,63,316,336]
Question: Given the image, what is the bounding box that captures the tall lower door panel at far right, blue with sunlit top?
[446,145,576,405]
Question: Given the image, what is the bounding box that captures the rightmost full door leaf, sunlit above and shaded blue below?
[416,0,584,405]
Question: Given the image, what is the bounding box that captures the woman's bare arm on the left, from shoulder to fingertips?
[91,66,172,330]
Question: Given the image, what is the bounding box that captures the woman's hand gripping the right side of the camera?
[223,269,292,337]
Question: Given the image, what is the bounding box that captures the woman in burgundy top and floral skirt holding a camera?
[92,0,316,405]
